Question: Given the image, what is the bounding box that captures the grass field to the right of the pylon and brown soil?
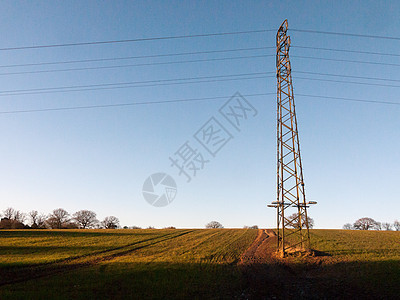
[311,230,400,299]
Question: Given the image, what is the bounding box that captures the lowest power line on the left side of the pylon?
[0,93,275,114]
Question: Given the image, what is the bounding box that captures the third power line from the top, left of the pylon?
[0,54,275,75]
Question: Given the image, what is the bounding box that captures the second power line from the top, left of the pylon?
[0,47,276,68]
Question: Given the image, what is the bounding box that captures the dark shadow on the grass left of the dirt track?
[0,263,243,299]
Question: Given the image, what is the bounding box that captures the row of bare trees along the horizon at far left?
[0,207,120,229]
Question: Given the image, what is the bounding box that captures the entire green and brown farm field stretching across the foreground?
[0,229,400,299]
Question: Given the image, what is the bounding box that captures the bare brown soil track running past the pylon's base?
[238,229,376,299]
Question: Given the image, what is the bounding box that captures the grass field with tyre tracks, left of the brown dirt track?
[0,229,257,299]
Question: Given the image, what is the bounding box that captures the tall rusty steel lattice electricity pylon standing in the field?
[268,20,316,257]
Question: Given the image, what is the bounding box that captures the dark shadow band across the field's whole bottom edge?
[0,260,400,299]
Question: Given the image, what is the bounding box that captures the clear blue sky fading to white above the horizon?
[0,1,400,228]
